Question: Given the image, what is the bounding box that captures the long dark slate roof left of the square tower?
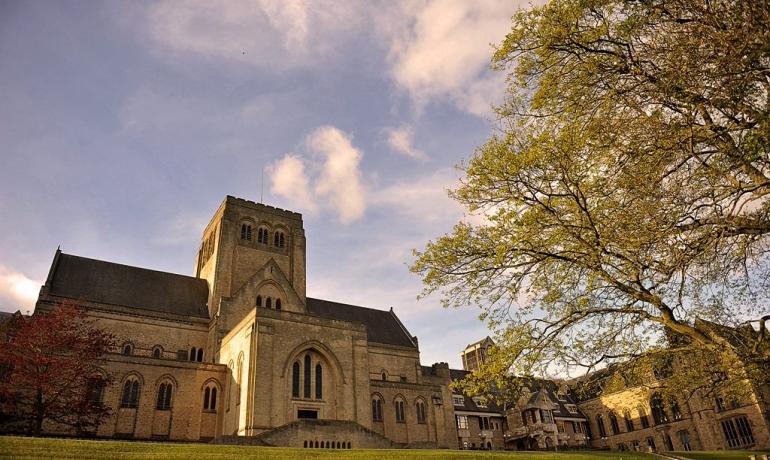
[46,251,209,319]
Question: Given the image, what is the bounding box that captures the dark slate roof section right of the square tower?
[307,297,417,348]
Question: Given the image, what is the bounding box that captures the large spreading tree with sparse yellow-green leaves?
[412,0,770,396]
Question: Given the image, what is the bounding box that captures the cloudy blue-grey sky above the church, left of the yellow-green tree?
[0,0,529,368]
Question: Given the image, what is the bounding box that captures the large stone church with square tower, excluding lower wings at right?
[36,196,457,448]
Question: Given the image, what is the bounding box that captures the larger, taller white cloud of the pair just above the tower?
[307,126,366,223]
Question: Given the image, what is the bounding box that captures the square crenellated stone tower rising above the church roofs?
[195,195,306,345]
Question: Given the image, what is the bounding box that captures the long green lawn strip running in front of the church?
[0,436,655,460]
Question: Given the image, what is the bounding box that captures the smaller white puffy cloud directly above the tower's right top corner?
[267,153,318,215]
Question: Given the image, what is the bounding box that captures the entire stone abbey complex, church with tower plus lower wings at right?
[27,196,770,451]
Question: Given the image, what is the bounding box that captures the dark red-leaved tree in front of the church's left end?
[0,303,115,435]
